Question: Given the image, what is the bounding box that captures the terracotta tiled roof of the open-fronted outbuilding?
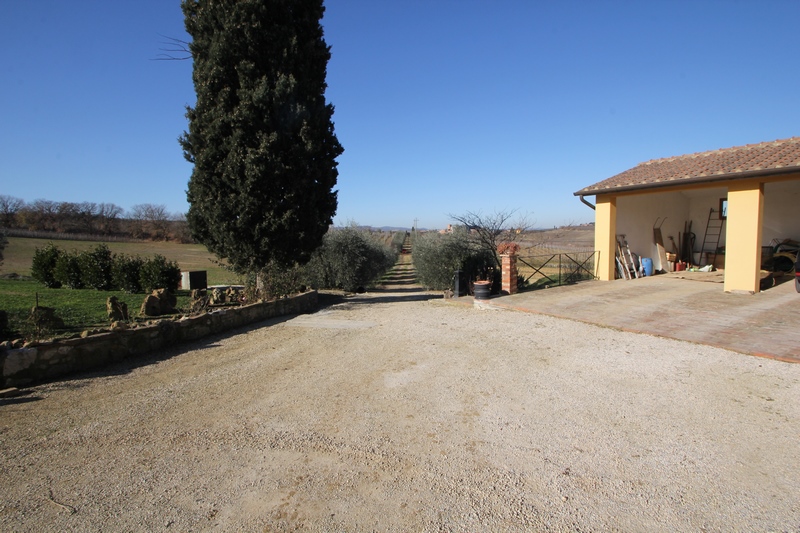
[575,137,800,196]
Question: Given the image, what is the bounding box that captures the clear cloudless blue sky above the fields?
[0,0,800,228]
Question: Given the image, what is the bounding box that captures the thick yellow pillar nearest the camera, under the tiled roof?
[725,181,764,293]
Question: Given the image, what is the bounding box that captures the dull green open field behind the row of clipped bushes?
[0,237,243,286]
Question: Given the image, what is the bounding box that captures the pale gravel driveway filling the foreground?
[0,258,800,531]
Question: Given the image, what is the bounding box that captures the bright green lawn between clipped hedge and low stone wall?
[0,279,189,338]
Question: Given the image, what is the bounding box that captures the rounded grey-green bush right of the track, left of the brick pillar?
[412,228,495,290]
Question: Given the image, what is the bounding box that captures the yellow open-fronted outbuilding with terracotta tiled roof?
[575,137,800,293]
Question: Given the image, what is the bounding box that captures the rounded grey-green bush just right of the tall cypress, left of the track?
[304,228,397,292]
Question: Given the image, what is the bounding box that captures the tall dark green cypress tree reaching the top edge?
[180,0,343,273]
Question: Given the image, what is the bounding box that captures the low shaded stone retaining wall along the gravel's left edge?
[0,291,319,388]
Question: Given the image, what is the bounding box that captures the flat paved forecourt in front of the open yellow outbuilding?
[482,273,800,363]
